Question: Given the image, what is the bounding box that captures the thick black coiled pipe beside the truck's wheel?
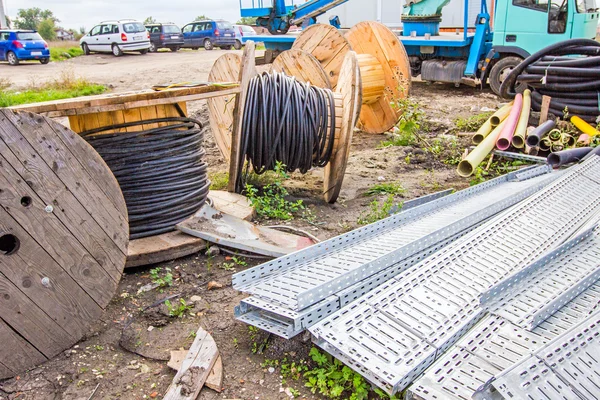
[500,39,600,122]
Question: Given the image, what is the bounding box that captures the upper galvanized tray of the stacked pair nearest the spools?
[233,166,555,311]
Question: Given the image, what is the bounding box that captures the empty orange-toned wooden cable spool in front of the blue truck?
[288,21,410,133]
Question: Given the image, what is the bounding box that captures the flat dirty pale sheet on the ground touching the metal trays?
[177,204,314,257]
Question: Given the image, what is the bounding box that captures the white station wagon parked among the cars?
[79,19,150,57]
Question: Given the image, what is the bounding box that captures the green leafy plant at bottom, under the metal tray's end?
[304,347,370,400]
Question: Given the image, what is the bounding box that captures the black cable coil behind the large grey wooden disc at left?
[81,117,210,239]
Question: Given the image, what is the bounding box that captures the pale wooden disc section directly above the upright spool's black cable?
[271,49,331,89]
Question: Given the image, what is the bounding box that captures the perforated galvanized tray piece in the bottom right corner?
[491,311,600,400]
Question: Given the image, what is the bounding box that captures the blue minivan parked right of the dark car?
[181,20,235,50]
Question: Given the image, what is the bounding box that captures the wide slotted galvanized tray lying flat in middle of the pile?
[310,157,600,393]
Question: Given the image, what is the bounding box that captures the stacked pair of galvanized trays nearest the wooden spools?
[233,166,560,338]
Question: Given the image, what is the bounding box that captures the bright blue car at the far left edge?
[0,29,50,65]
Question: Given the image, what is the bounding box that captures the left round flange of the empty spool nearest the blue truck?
[292,24,351,89]
